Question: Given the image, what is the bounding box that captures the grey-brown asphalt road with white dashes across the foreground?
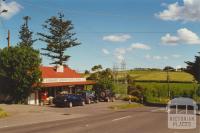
[0,107,199,133]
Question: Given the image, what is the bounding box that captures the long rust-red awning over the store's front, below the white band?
[41,81,95,88]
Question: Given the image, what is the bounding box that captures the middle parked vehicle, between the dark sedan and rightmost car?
[78,90,98,104]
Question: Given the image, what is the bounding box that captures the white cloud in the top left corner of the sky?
[0,1,23,19]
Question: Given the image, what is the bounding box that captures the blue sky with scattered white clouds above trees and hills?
[0,0,200,71]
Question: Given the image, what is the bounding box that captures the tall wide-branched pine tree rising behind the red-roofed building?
[38,13,80,65]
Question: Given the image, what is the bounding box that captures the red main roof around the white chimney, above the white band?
[40,66,81,78]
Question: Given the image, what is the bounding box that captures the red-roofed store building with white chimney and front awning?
[28,66,95,105]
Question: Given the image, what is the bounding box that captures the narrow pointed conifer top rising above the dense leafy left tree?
[18,16,36,47]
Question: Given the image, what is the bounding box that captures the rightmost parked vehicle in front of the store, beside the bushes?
[96,89,115,102]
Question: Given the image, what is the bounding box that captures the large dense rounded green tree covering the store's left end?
[0,46,41,103]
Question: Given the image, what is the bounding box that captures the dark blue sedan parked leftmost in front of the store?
[53,94,85,108]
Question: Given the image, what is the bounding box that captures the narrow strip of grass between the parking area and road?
[109,103,144,110]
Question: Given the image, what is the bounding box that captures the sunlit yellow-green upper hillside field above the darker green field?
[119,70,193,82]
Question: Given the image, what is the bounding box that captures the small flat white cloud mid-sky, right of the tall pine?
[103,34,131,42]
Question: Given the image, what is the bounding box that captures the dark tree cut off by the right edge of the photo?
[185,53,200,83]
